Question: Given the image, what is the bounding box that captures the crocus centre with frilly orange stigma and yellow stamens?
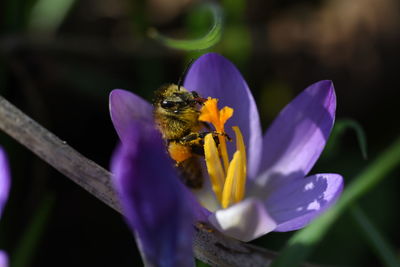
[199,97,247,208]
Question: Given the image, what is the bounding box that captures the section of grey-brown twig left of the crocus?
[0,96,120,211]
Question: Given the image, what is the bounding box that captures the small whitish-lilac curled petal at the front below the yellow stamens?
[208,198,276,242]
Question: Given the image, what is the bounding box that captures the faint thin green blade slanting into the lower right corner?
[350,205,400,267]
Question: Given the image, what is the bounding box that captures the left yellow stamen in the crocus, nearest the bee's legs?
[204,134,225,203]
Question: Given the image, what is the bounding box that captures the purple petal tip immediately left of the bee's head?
[109,89,153,143]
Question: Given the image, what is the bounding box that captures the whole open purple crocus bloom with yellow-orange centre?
[110,53,343,264]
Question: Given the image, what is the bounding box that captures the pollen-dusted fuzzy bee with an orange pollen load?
[153,84,208,189]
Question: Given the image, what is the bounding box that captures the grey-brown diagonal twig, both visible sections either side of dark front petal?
[0,96,308,267]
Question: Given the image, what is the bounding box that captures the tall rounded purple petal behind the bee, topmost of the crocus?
[184,53,262,180]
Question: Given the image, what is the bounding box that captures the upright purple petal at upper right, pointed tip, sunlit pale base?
[257,81,336,186]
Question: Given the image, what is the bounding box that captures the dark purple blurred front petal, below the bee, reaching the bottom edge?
[112,122,194,266]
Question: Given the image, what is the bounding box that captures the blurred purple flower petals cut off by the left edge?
[0,148,10,267]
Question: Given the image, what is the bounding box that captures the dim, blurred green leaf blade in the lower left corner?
[11,195,54,267]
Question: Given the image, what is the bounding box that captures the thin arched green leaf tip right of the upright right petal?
[325,119,368,159]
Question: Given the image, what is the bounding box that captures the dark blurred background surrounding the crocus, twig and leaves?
[0,0,400,266]
